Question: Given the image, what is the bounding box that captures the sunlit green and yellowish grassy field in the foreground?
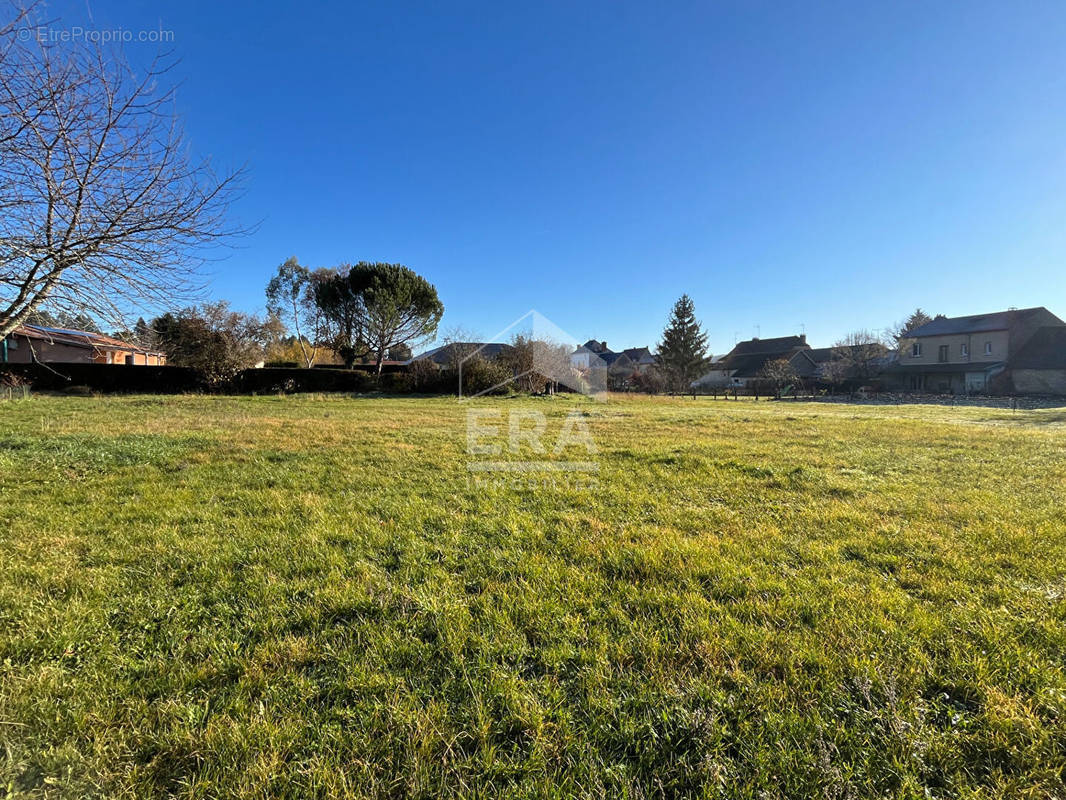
[0,397,1066,798]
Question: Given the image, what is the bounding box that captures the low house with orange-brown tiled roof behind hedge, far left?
[0,325,166,366]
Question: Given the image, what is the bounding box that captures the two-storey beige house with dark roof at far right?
[885,306,1066,394]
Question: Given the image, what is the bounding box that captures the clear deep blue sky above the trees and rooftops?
[45,0,1066,353]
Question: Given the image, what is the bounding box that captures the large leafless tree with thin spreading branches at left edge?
[0,5,241,337]
